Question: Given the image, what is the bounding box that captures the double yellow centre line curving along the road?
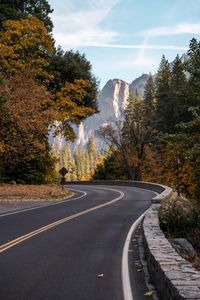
[0,190,124,253]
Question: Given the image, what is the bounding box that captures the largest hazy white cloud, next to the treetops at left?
[52,0,120,48]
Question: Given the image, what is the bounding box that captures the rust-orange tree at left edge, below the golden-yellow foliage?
[0,74,54,183]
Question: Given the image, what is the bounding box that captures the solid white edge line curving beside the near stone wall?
[121,210,147,300]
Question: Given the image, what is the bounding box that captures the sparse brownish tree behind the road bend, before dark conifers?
[123,92,156,180]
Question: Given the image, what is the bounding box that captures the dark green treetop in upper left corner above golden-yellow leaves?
[0,0,53,31]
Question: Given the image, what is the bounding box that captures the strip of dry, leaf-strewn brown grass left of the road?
[0,184,71,201]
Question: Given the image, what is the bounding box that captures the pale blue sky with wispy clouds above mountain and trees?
[49,0,200,87]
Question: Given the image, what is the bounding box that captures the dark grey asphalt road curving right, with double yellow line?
[0,185,155,300]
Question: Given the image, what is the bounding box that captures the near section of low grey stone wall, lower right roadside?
[143,204,200,300]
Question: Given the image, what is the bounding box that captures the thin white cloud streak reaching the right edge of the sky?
[142,23,200,37]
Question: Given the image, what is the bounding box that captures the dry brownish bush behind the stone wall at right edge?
[159,193,200,270]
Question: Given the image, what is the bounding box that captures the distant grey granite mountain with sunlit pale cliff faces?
[72,74,148,149]
